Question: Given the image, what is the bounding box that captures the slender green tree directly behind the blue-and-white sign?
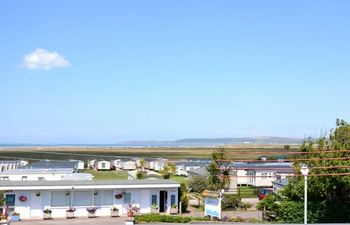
[207,149,231,191]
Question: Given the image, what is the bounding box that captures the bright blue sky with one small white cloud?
[0,0,350,143]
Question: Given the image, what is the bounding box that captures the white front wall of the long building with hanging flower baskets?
[5,188,178,219]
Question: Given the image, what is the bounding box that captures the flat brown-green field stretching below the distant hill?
[0,145,293,161]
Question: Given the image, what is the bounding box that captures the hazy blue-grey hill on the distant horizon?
[118,137,303,147]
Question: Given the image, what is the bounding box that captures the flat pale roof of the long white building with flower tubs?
[0,179,180,190]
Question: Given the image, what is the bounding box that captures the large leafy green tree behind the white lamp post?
[261,119,350,223]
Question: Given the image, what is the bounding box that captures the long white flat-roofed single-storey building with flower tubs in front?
[0,179,180,219]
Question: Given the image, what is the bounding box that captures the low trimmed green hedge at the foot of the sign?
[135,213,209,223]
